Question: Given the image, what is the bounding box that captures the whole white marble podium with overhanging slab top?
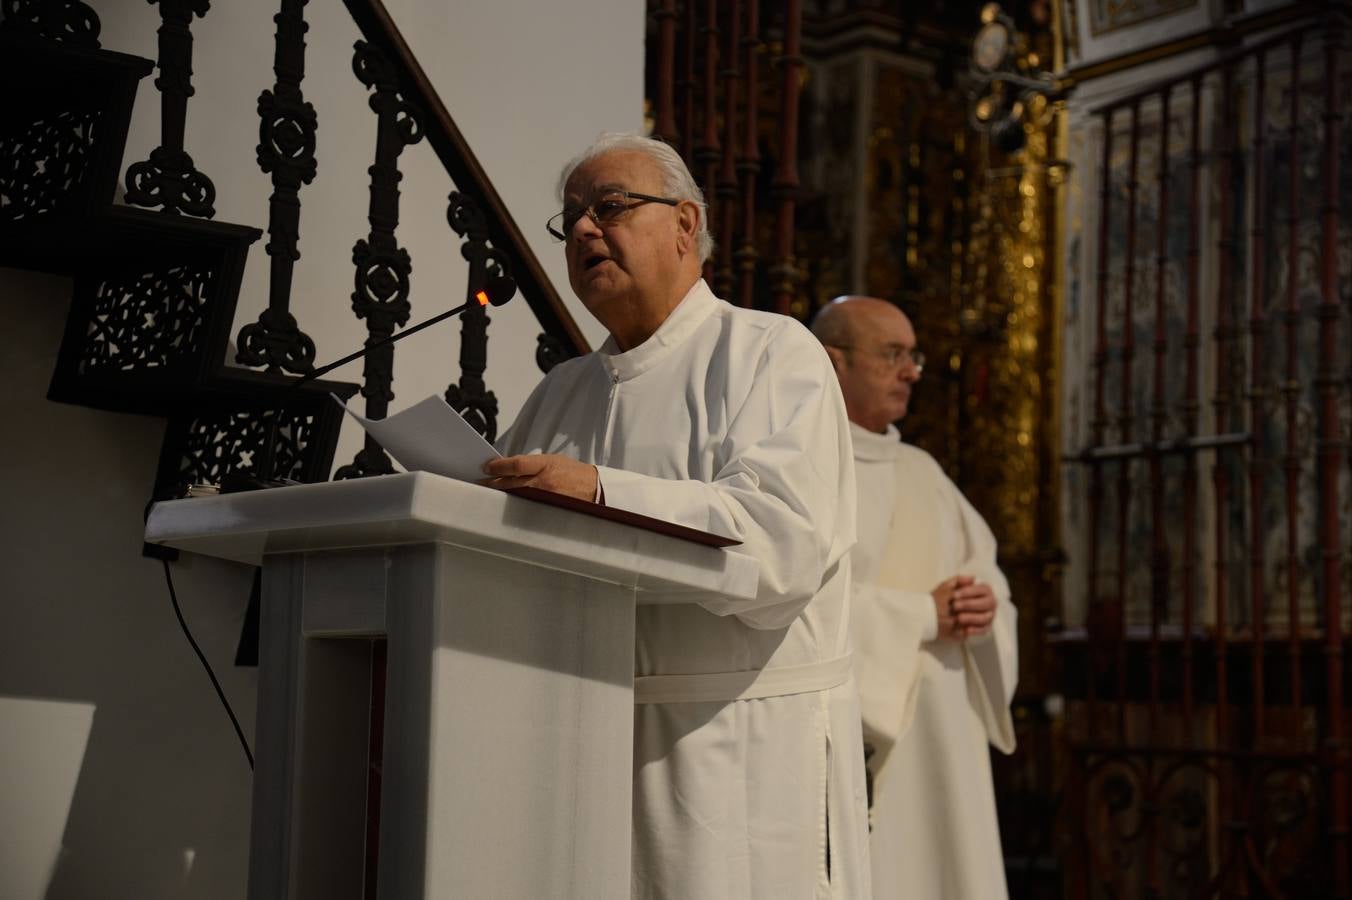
[146,473,758,900]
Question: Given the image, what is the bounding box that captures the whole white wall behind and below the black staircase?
[0,0,644,900]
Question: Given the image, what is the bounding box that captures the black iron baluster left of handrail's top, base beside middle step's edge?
[235,0,319,373]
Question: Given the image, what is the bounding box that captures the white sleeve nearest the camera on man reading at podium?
[598,322,854,628]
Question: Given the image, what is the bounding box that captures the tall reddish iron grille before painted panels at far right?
[1063,5,1352,897]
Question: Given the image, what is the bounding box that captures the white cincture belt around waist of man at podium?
[634,653,853,703]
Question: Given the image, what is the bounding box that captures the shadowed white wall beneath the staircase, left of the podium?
[0,272,256,900]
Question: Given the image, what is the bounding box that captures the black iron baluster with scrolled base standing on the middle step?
[127,0,216,219]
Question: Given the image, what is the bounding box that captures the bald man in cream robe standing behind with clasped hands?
[813,297,1018,900]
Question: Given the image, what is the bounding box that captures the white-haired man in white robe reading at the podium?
[485,134,869,900]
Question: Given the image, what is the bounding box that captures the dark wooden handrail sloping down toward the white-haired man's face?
[343,0,591,355]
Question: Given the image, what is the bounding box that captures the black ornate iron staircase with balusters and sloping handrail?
[0,0,587,496]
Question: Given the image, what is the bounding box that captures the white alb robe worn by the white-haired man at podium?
[499,281,869,900]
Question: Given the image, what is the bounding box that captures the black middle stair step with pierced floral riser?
[38,207,357,416]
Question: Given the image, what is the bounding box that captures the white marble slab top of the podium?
[146,472,760,599]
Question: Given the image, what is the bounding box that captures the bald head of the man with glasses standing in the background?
[813,295,921,432]
